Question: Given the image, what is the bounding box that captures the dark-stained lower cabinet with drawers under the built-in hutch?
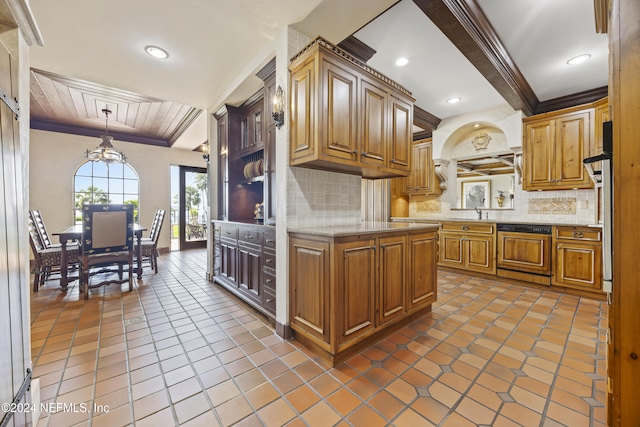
[213,221,276,317]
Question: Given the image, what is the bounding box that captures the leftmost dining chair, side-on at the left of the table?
[29,217,78,292]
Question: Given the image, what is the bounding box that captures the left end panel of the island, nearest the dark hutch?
[289,237,330,345]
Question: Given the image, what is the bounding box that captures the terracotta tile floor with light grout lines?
[31,250,606,427]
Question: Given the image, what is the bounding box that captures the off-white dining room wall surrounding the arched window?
[29,130,206,248]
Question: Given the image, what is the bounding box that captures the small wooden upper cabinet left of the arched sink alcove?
[397,138,442,195]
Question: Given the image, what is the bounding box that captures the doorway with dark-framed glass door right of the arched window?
[171,166,209,251]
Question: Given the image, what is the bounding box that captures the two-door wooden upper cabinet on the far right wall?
[522,106,594,191]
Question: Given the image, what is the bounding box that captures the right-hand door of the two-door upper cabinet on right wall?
[554,111,593,189]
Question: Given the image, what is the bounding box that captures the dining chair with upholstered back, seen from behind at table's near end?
[80,204,134,299]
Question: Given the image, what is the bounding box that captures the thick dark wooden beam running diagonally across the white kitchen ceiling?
[413,0,538,115]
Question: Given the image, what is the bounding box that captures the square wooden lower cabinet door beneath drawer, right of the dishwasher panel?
[552,242,602,291]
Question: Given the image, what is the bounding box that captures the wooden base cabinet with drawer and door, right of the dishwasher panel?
[551,226,602,292]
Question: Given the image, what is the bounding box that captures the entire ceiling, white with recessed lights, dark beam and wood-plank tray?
[30,0,608,149]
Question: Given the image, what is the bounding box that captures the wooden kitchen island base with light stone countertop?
[288,222,440,366]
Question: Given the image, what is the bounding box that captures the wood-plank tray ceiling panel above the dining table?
[30,69,203,147]
